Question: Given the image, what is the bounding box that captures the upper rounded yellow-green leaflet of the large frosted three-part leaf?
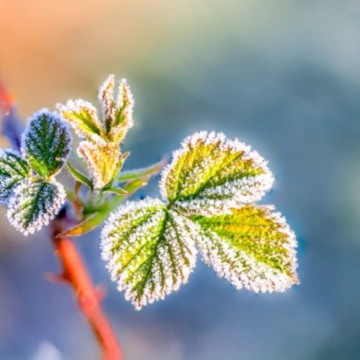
[160,132,273,215]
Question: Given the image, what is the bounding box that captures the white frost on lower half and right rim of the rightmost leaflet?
[197,206,298,293]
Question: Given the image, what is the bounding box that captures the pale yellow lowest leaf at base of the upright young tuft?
[78,141,122,189]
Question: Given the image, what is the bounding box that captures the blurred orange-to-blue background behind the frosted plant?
[0,0,360,360]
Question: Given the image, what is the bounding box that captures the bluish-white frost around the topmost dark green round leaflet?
[21,108,72,175]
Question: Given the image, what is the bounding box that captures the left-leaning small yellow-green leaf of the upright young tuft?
[56,100,105,144]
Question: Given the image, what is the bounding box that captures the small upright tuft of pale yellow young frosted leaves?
[57,75,134,189]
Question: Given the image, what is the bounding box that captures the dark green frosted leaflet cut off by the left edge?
[0,150,30,205]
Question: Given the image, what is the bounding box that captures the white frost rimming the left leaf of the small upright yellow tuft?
[56,99,105,145]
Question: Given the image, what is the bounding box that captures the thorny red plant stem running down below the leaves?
[52,218,123,360]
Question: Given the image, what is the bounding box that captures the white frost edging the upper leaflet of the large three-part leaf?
[159,131,274,214]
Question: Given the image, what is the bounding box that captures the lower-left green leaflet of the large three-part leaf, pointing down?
[101,199,198,309]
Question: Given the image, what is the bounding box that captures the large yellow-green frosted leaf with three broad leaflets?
[101,132,298,309]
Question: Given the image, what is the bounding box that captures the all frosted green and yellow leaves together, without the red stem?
[0,76,298,309]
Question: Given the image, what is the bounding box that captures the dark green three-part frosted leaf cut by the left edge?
[0,109,71,235]
